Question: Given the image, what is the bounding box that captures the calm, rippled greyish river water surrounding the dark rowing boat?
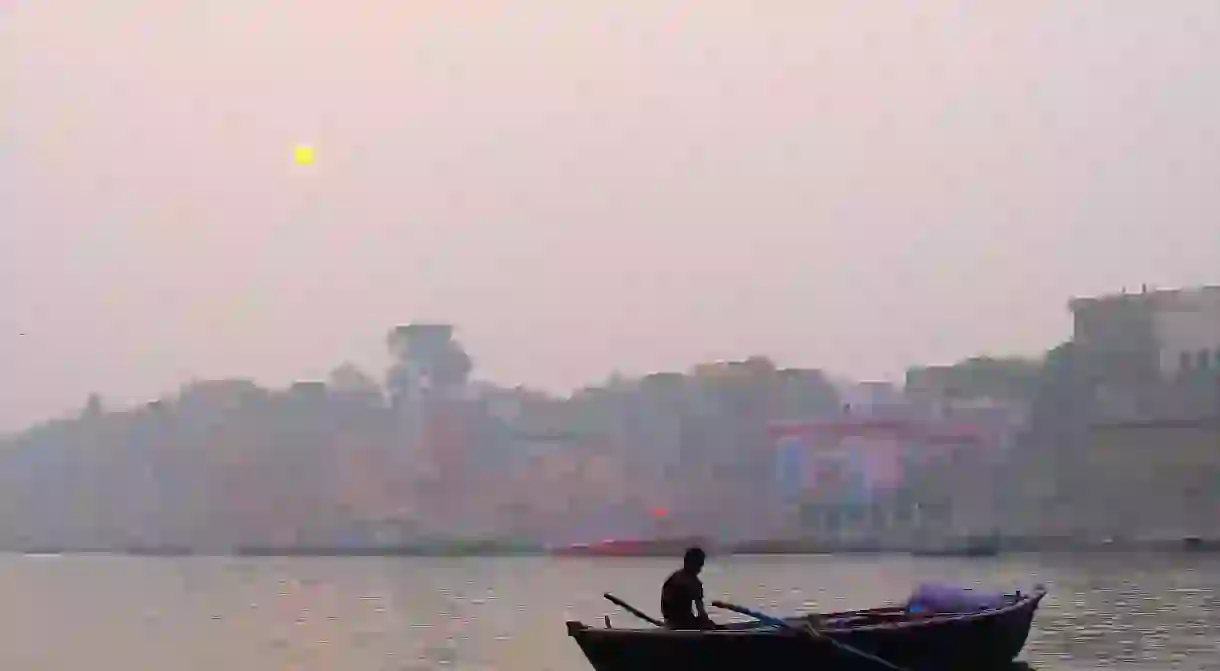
[0,554,1220,671]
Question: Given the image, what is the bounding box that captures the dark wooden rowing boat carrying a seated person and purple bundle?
[567,586,1046,671]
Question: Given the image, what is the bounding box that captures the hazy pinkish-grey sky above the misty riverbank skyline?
[0,0,1220,428]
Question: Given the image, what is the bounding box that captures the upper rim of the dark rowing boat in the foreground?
[569,586,1047,638]
